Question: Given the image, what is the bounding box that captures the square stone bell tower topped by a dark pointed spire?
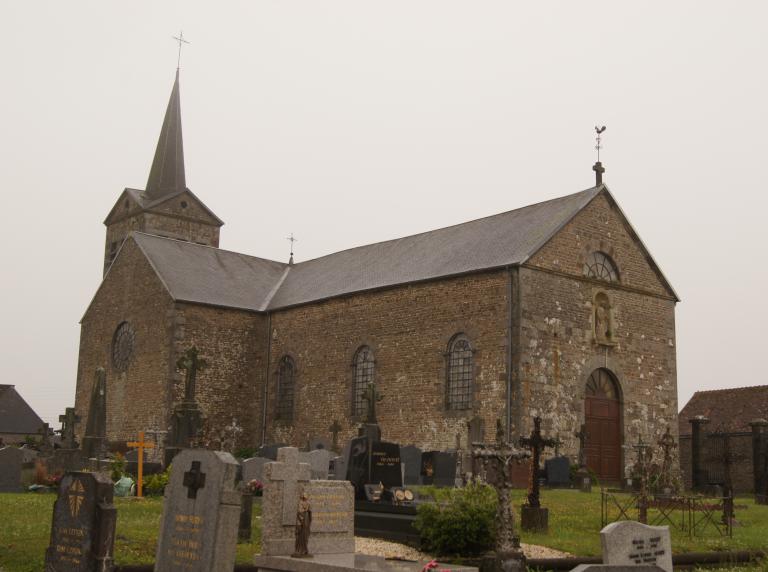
[104,69,224,275]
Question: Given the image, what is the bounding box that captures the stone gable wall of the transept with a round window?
[75,240,172,441]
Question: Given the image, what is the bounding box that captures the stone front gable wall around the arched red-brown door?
[519,190,678,476]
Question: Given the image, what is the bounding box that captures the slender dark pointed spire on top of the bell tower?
[146,69,187,199]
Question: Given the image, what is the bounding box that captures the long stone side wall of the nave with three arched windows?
[267,271,509,449]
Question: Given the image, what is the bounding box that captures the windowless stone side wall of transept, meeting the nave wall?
[173,303,268,447]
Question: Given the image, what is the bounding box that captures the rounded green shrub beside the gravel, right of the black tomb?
[414,483,497,556]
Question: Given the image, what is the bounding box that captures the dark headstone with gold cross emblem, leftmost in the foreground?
[45,472,117,572]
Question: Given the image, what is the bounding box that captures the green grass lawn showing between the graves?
[0,490,768,572]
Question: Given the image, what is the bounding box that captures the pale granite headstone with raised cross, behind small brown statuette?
[261,447,355,556]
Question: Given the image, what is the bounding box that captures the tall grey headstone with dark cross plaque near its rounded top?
[155,449,241,572]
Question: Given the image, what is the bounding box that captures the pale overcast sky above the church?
[0,0,768,427]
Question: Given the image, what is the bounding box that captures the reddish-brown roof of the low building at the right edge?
[678,385,768,435]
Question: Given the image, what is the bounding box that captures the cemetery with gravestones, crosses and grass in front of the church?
[0,374,768,572]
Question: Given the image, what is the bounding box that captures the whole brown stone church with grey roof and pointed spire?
[76,72,678,481]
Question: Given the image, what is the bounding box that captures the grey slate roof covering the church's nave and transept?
[118,185,663,312]
